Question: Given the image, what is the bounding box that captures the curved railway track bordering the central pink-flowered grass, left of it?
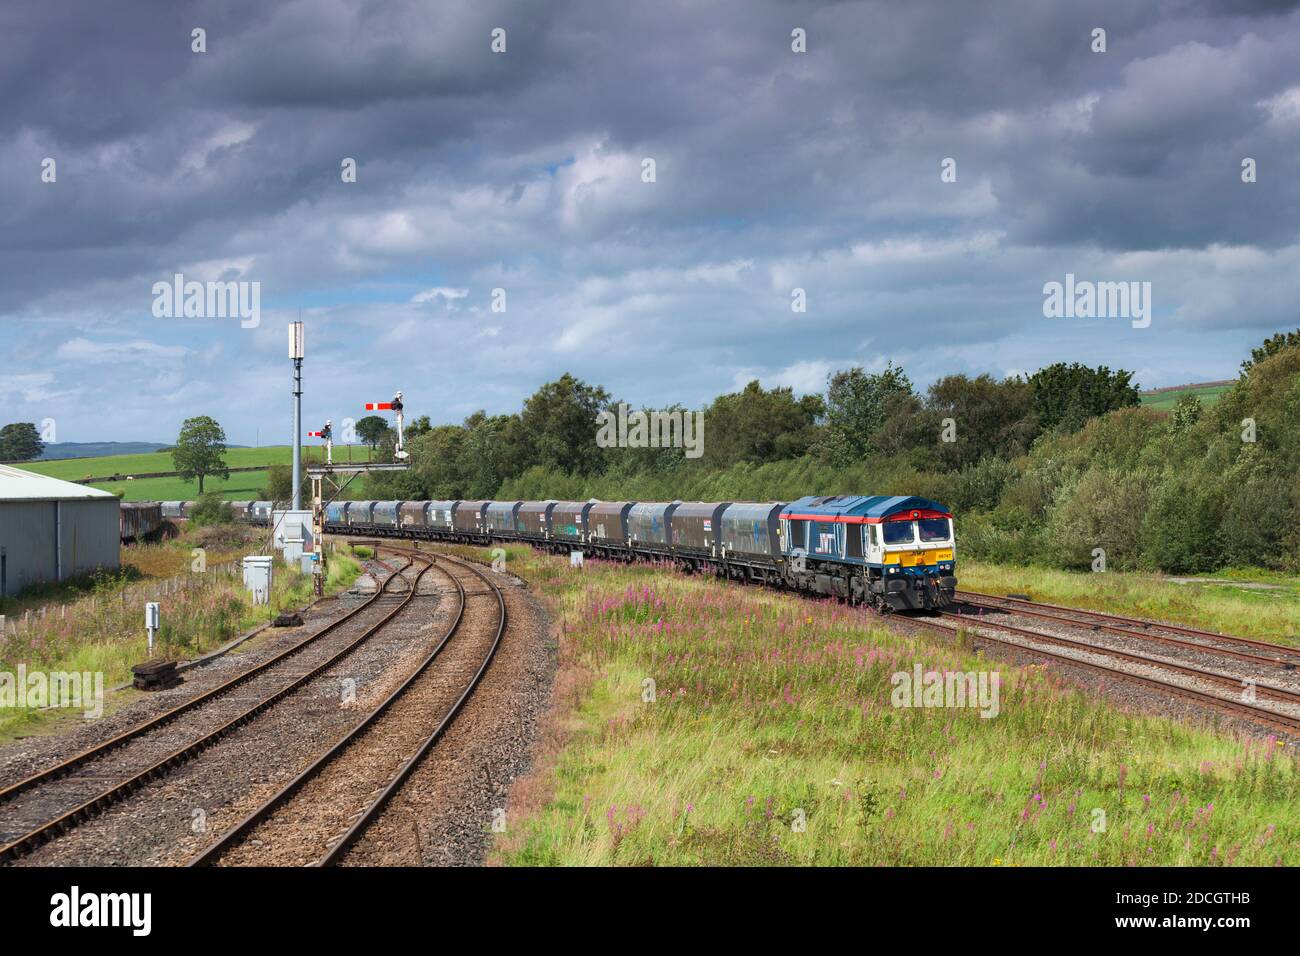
[189,554,507,866]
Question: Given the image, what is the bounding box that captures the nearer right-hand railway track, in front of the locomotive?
[909,611,1300,737]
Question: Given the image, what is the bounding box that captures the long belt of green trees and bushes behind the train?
[358,330,1300,572]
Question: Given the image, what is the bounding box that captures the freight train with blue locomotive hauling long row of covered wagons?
[131,494,957,611]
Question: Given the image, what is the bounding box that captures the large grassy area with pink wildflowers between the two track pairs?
[495,548,1300,866]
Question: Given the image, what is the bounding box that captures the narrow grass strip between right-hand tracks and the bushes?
[958,561,1300,645]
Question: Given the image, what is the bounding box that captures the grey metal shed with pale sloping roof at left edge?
[0,464,121,597]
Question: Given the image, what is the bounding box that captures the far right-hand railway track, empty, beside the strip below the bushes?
[957,591,1300,670]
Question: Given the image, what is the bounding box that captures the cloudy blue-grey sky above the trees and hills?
[0,0,1300,445]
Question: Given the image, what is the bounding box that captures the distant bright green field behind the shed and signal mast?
[18,445,365,501]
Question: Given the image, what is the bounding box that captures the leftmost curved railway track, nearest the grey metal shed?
[0,549,433,862]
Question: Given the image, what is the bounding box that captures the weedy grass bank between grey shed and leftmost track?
[0,527,361,740]
